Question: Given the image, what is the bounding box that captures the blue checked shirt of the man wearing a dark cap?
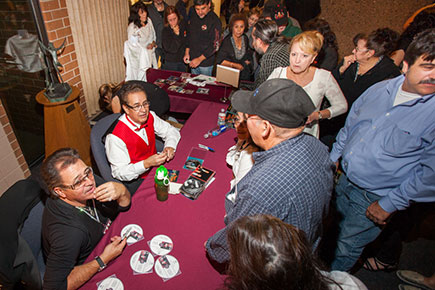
[206,134,333,263]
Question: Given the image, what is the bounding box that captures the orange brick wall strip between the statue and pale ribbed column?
[39,0,88,116]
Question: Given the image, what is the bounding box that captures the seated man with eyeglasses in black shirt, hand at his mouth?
[41,148,131,289]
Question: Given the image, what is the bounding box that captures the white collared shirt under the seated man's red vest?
[105,111,181,181]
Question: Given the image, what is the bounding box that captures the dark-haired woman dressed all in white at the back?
[124,1,157,81]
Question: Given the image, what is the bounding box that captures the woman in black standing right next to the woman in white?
[162,6,187,72]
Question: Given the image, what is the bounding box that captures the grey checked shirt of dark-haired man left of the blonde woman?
[255,42,290,88]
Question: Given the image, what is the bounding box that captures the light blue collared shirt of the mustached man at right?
[331,76,435,212]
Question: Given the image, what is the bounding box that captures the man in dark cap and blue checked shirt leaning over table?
[206,79,334,263]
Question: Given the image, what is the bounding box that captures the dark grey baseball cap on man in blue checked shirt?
[231,79,316,128]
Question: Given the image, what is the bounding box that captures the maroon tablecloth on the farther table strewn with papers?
[147,68,232,113]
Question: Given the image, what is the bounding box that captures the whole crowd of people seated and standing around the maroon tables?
[34,0,435,289]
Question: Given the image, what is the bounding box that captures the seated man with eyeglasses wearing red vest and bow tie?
[105,83,181,194]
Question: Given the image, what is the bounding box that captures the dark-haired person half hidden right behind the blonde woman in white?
[304,18,338,71]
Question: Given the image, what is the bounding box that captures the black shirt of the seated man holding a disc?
[42,176,129,289]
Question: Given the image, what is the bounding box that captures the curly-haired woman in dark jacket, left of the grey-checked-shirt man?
[216,14,253,80]
